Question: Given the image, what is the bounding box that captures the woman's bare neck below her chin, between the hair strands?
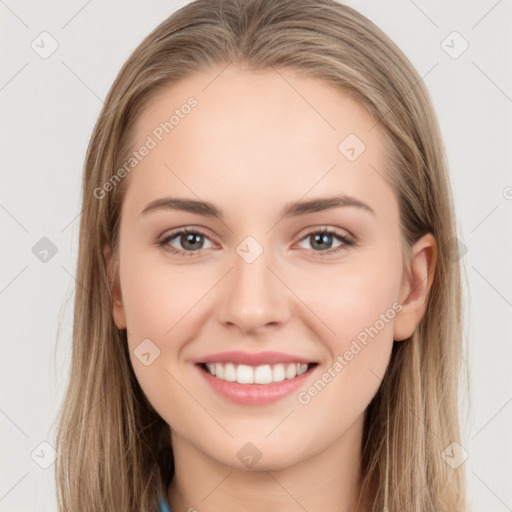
[168,417,367,512]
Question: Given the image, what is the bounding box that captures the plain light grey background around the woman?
[0,0,512,512]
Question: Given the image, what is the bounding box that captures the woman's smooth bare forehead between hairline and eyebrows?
[125,66,393,220]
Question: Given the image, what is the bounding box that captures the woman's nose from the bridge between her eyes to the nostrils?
[215,237,290,331]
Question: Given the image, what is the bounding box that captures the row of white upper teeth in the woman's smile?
[202,363,308,384]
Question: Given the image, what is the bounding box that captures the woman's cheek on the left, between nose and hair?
[120,251,218,416]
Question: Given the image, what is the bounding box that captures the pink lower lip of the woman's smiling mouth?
[197,366,316,405]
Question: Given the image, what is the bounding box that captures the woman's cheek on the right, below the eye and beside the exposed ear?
[286,251,401,414]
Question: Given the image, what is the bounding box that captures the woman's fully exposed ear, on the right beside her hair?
[393,233,437,341]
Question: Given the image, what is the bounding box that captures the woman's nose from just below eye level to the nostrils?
[217,245,293,334]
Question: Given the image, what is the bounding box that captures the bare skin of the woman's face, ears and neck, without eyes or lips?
[104,66,436,512]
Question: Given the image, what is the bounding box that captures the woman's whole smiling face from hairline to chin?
[105,67,432,469]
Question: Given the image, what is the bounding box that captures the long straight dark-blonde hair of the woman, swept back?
[56,0,467,512]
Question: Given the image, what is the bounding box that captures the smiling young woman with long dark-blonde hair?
[57,0,466,512]
